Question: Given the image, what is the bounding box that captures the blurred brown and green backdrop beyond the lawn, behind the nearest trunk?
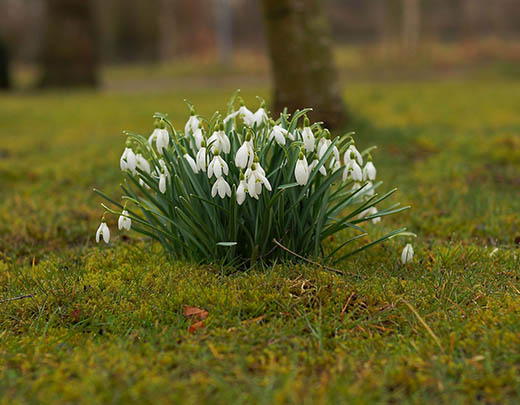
[0,0,520,90]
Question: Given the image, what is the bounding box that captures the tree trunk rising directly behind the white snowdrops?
[262,0,345,127]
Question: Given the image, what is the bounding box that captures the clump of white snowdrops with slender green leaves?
[95,96,408,265]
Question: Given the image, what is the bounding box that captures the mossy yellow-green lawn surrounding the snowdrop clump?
[0,68,520,404]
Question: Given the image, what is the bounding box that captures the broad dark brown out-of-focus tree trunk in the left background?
[41,0,99,87]
